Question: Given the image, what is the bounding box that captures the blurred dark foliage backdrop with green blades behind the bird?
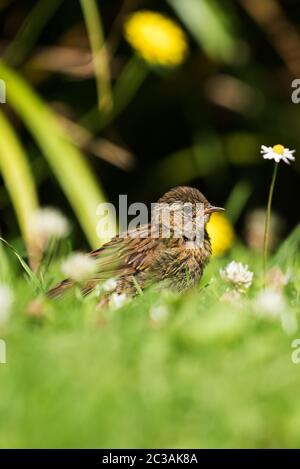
[0,0,300,252]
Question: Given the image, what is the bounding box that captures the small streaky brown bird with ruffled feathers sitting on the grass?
[48,186,224,298]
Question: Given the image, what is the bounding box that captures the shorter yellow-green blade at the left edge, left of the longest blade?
[0,112,38,252]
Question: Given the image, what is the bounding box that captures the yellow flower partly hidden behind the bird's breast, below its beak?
[207,213,234,256]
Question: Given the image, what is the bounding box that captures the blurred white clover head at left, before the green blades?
[31,207,70,249]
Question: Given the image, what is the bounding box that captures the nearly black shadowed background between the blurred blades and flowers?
[0,0,300,249]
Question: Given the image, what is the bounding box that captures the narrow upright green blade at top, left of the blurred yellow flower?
[80,0,113,114]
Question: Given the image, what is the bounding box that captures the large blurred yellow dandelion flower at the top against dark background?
[125,10,188,67]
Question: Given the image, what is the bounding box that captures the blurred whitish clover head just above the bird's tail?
[61,252,98,282]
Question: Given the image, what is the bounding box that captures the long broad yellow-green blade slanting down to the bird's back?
[0,61,114,248]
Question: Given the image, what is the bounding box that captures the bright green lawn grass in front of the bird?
[0,243,300,448]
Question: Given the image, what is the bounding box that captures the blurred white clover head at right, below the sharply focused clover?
[254,288,288,318]
